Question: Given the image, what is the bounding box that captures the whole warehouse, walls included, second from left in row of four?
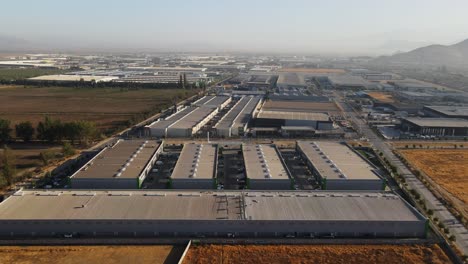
[171,143,218,189]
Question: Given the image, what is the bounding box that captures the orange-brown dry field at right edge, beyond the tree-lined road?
[400,149,468,208]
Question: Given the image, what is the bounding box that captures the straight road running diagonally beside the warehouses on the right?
[336,94,468,255]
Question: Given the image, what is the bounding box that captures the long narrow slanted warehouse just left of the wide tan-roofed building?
[214,96,261,137]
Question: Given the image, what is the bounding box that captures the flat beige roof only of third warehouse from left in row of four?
[242,144,289,180]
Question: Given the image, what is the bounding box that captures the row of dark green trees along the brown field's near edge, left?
[0,117,98,144]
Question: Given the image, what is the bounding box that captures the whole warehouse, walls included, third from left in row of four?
[242,144,293,190]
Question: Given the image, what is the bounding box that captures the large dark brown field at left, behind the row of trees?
[0,86,195,133]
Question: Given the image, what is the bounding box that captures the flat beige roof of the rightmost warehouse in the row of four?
[297,141,380,180]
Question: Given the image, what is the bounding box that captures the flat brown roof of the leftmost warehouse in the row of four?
[72,139,160,179]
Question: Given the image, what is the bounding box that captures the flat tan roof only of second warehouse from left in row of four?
[171,143,216,180]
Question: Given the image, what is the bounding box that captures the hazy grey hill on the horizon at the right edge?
[374,39,468,66]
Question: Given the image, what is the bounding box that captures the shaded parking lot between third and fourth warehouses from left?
[280,149,320,190]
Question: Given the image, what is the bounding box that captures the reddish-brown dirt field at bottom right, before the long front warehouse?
[184,245,450,264]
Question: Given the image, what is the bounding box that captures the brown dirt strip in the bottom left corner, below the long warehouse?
[0,246,183,264]
